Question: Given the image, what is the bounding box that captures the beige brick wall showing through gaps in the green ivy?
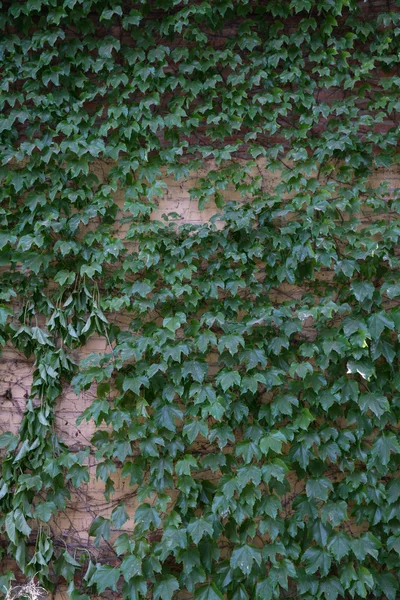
[0,162,400,600]
